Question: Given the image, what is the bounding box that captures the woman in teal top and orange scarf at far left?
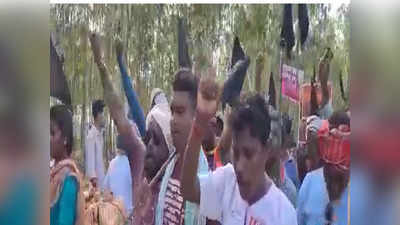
[49,105,82,225]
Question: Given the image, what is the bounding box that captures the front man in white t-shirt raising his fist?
[181,78,297,225]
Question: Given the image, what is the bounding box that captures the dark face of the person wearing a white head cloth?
[144,119,169,179]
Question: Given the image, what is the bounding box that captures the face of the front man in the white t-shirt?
[232,128,268,200]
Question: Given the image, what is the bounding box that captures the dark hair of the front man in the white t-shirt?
[229,94,271,145]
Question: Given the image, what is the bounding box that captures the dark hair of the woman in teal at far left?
[50,105,73,155]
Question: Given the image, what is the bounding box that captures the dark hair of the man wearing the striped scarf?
[172,69,199,108]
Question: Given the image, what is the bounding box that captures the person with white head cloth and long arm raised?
[90,34,173,225]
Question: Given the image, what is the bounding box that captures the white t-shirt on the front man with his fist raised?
[199,164,297,225]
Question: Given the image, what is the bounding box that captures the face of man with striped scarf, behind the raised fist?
[171,91,195,153]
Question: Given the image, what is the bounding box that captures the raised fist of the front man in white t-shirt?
[196,67,220,125]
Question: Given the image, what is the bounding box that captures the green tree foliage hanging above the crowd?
[50,4,350,160]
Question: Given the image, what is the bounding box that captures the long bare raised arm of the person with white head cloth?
[90,34,145,185]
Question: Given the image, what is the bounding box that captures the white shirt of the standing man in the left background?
[85,125,104,185]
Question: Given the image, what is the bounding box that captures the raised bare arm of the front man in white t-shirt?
[181,69,219,204]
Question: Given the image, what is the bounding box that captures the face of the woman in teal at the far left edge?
[50,120,66,159]
